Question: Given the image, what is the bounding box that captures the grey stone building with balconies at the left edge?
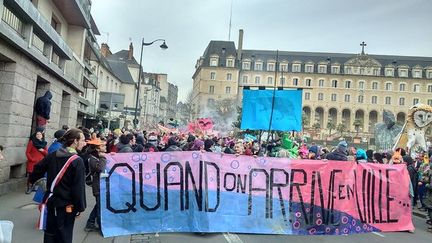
[0,0,99,194]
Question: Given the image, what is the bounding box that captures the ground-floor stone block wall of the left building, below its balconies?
[0,40,78,193]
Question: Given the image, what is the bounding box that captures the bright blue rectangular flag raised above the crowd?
[240,90,302,131]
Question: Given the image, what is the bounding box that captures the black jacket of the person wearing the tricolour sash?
[29,148,86,212]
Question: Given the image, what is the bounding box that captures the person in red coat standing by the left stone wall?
[26,128,48,194]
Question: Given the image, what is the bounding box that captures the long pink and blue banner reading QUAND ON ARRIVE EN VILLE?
[101,152,414,236]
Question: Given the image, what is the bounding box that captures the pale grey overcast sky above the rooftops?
[92,0,432,101]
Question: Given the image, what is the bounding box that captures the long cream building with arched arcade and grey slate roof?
[192,31,432,137]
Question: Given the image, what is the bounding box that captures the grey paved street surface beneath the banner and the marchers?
[0,183,432,243]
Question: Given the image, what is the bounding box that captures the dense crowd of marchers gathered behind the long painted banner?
[0,126,432,242]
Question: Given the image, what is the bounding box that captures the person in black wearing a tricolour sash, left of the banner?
[29,129,86,243]
